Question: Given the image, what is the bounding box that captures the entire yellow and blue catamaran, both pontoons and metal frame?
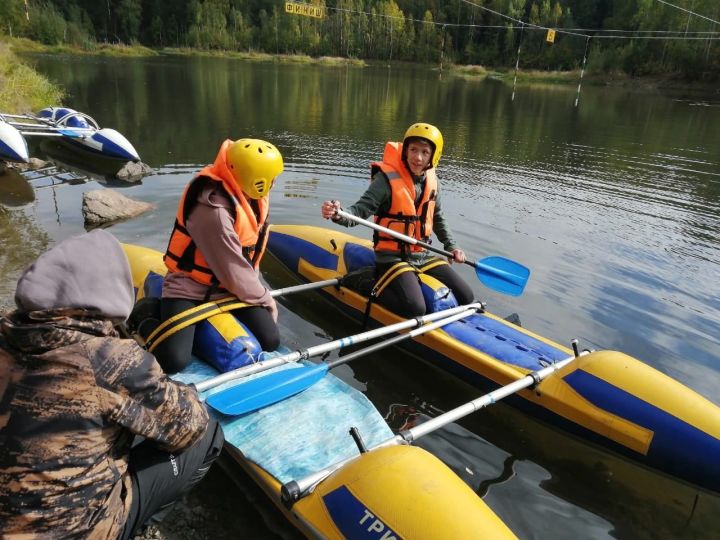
[124,225,720,538]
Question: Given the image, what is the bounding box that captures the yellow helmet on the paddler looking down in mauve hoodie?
[226,139,283,199]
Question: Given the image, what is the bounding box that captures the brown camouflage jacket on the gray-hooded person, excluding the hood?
[0,312,208,539]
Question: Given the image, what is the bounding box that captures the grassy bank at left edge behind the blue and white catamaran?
[0,41,63,113]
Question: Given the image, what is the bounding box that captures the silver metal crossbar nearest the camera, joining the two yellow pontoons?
[281,351,588,502]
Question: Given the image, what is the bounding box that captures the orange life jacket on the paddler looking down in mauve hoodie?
[163,140,270,285]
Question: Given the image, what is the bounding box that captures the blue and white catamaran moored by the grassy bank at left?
[0,107,140,163]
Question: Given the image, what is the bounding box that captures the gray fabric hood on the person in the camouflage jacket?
[15,229,135,321]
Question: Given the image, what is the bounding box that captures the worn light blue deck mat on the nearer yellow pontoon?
[173,350,393,483]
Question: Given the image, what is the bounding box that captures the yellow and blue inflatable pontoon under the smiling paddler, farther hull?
[268,225,720,492]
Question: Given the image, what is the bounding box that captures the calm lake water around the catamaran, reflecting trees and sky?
[0,56,720,539]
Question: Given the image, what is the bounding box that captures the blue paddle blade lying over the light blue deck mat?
[206,364,328,416]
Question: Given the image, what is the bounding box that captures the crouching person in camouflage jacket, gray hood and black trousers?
[0,230,223,539]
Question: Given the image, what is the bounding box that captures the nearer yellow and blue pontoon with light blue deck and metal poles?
[123,245,516,540]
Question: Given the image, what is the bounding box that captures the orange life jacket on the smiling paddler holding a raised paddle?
[370,142,437,256]
